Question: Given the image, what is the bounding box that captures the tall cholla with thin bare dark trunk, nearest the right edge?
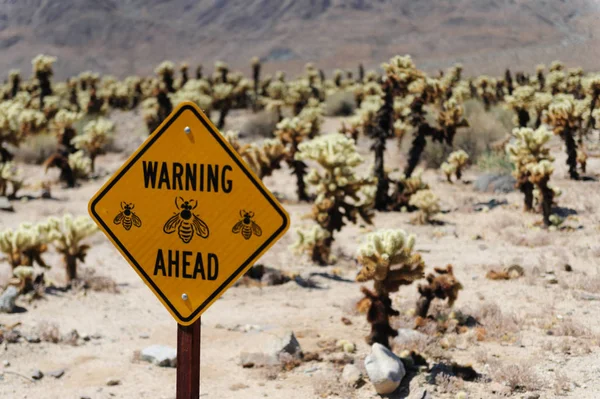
[544,94,585,180]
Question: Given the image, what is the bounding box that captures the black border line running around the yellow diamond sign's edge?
[90,104,289,323]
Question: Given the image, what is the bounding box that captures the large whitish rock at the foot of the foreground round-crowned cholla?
[365,343,406,395]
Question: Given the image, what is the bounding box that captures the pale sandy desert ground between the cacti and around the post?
[0,110,600,399]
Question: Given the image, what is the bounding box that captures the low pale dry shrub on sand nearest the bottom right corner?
[490,361,543,392]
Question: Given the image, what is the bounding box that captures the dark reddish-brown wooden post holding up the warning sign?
[177,319,201,399]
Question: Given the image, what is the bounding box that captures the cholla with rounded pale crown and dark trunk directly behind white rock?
[356,229,425,348]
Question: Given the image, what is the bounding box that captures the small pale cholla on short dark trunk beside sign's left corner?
[49,214,98,284]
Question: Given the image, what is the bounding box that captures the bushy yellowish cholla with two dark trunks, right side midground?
[507,126,560,226]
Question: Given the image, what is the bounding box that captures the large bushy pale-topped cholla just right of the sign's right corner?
[296,134,374,265]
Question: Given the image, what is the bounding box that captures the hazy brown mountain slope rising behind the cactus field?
[0,0,600,78]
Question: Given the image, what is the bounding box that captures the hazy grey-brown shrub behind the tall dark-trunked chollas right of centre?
[421,100,513,168]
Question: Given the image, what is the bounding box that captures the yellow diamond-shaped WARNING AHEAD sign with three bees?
[89,102,289,325]
